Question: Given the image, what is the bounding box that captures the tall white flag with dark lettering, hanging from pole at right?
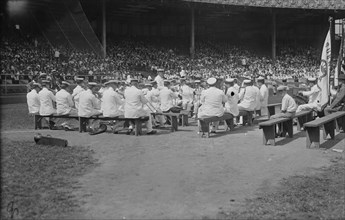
[317,31,331,109]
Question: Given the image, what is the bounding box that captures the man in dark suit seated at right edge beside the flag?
[324,74,345,115]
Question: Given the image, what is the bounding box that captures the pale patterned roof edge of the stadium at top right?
[184,0,345,10]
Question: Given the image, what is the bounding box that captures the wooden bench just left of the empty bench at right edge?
[259,111,312,145]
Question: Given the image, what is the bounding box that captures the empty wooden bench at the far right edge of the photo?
[304,111,345,148]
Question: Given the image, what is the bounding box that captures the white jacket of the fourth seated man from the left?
[78,89,101,118]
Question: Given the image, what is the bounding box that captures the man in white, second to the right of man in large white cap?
[238,79,257,111]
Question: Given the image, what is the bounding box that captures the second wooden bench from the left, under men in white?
[79,115,149,136]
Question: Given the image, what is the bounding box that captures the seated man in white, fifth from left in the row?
[102,80,124,133]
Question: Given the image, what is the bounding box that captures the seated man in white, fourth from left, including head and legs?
[78,82,102,132]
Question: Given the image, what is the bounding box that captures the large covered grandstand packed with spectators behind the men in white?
[1,0,345,103]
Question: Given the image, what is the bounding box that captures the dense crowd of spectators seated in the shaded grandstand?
[0,29,320,83]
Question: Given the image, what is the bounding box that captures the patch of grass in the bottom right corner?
[219,155,345,220]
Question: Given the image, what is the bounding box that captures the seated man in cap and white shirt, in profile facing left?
[270,86,297,136]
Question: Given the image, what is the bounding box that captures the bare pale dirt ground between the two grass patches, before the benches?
[1,121,345,219]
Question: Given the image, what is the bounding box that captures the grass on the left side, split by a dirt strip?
[1,104,97,219]
